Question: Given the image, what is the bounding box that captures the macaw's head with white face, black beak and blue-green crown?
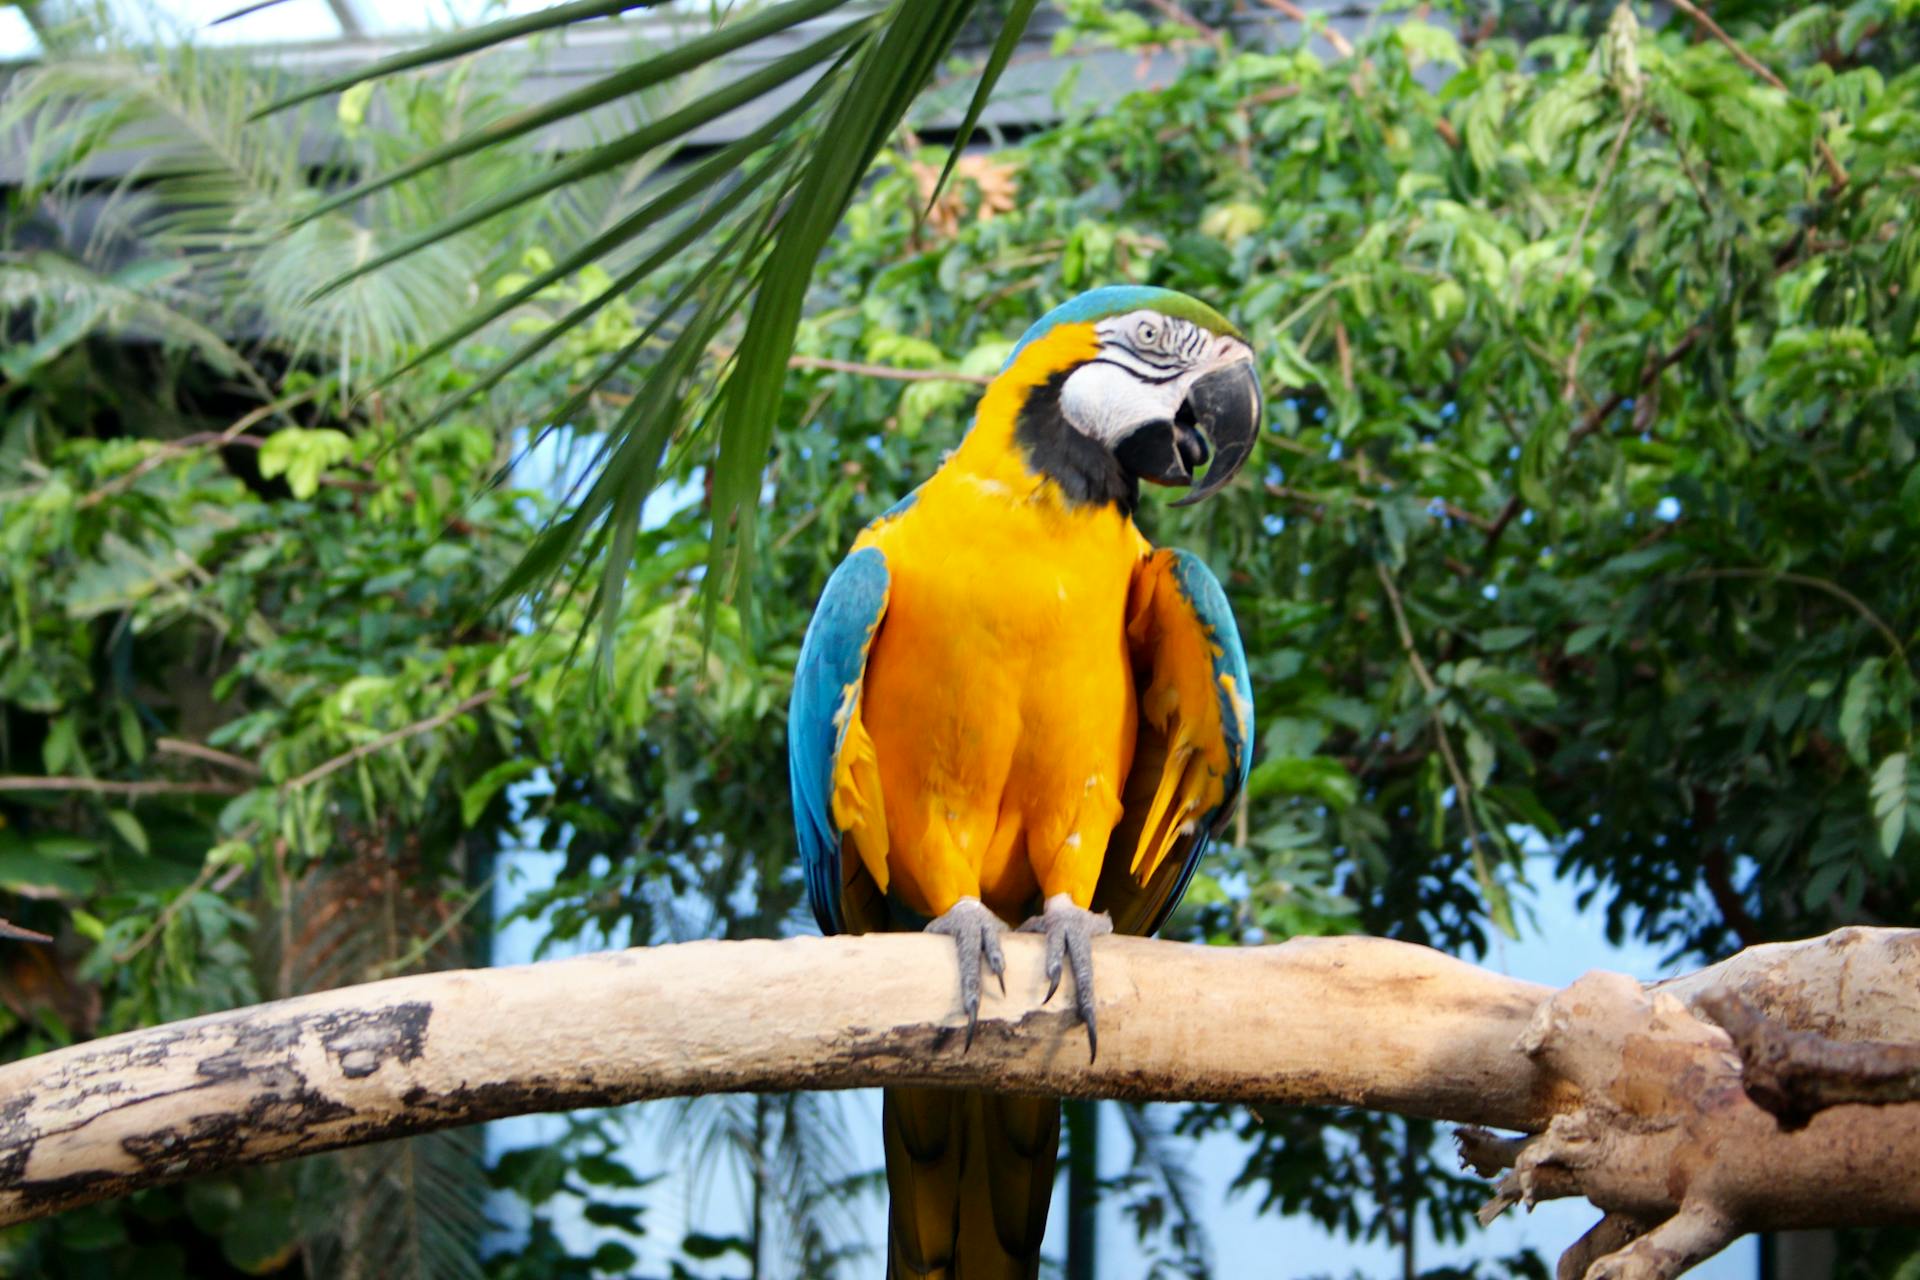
[1000,286,1261,509]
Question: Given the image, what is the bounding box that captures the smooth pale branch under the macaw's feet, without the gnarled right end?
[0,935,1571,1224]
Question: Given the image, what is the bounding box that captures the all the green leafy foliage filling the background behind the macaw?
[0,2,1920,1276]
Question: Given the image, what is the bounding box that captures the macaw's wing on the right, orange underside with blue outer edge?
[1094,551,1254,933]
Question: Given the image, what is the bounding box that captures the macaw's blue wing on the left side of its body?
[787,547,891,933]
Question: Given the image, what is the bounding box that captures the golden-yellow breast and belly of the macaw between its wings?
[860,472,1146,921]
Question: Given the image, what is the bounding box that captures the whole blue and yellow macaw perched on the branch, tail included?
[787,288,1261,1280]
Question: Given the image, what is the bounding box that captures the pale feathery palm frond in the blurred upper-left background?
[0,22,591,393]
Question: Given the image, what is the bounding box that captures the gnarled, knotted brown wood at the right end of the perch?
[1461,959,1920,1280]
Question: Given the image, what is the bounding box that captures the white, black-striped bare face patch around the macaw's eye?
[1060,311,1250,449]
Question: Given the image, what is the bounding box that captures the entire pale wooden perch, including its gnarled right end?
[0,929,1920,1280]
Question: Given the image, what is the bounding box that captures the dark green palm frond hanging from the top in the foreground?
[264,0,1035,614]
